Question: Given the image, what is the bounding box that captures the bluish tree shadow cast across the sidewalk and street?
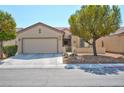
[65,65,124,75]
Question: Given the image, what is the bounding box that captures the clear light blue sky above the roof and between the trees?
[0,5,124,27]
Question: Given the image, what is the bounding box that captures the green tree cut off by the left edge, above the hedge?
[0,11,16,58]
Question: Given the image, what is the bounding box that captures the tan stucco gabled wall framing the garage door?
[18,24,63,53]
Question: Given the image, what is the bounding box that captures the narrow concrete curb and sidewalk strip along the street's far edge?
[0,64,124,69]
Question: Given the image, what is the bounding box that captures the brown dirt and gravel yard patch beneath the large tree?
[64,55,124,64]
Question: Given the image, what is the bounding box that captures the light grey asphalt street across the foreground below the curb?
[0,68,124,87]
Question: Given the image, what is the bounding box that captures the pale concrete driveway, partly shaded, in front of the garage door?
[0,54,63,67]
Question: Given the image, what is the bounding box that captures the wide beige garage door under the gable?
[22,38,58,53]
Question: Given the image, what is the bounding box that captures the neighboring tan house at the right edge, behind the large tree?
[97,27,124,53]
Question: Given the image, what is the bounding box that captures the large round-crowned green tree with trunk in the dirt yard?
[69,5,121,56]
